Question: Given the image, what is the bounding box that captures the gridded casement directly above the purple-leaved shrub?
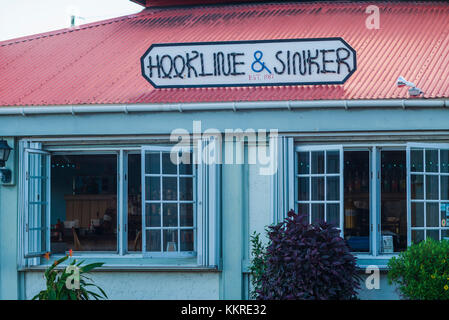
[295,145,344,233]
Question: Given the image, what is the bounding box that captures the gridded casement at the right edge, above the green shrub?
[407,143,449,245]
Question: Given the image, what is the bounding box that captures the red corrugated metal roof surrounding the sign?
[0,2,449,105]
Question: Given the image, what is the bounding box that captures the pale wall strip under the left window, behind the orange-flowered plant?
[25,272,219,300]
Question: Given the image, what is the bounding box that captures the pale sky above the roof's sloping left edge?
[0,0,143,41]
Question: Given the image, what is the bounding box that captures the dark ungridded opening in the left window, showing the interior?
[50,154,116,253]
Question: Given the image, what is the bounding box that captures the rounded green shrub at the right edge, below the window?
[388,239,449,300]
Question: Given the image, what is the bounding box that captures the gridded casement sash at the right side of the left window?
[143,148,195,253]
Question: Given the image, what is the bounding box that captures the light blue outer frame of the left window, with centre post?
[18,138,221,270]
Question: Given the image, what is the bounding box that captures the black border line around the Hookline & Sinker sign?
[140,37,357,89]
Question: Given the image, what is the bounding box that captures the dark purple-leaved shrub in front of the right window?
[256,210,360,300]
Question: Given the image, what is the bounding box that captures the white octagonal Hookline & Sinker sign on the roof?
[141,38,356,88]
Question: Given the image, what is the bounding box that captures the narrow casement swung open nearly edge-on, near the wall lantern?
[23,144,50,258]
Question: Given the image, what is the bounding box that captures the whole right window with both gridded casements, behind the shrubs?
[295,143,449,256]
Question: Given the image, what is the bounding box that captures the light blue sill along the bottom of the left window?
[19,255,219,272]
